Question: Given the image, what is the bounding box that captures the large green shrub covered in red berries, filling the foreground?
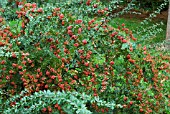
[0,0,170,114]
